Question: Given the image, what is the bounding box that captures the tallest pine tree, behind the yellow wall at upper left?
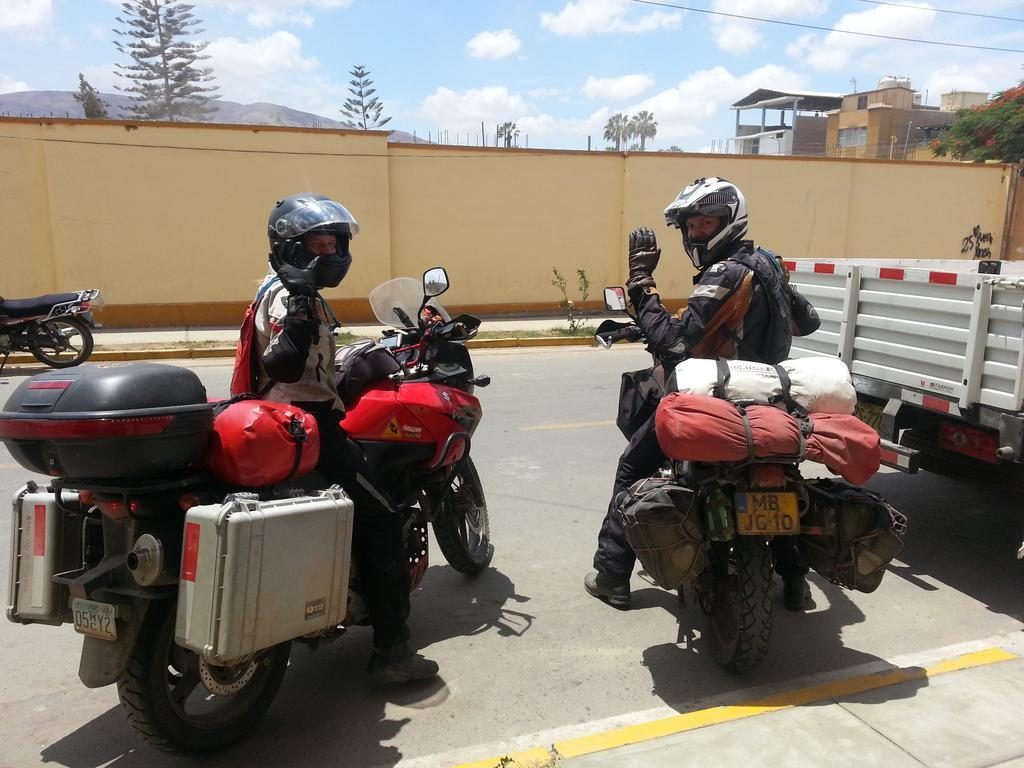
[114,0,218,120]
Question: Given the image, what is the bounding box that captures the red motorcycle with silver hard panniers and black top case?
[0,268,494,753]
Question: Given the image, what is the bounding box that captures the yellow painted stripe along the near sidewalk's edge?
[458,648,1018,768]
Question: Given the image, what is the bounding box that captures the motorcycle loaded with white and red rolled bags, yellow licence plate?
[596,287,906,672]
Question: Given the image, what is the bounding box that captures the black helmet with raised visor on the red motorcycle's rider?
[266,193,359,288]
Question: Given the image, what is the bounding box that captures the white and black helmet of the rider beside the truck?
[665,176,746,269]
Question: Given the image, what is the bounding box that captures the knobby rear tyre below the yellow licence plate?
[694,536,772,672]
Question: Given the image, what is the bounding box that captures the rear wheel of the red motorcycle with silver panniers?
[118,602,291,754]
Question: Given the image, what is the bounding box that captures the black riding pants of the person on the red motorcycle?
[303,403,410,648]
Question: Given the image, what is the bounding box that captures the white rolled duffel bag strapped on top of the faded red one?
[669,357,857,414]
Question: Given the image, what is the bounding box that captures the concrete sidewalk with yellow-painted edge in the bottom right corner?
[460,635,1024,768]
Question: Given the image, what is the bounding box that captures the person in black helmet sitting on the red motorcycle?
[254,193,437,680]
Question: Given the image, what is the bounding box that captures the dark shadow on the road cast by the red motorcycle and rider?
[41,565,534,768]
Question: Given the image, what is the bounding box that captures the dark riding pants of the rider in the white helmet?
[594,416,807,581]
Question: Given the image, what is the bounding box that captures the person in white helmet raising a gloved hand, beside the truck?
[584,177,820,610]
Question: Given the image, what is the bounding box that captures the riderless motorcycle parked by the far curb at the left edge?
[0,288,103,372]
